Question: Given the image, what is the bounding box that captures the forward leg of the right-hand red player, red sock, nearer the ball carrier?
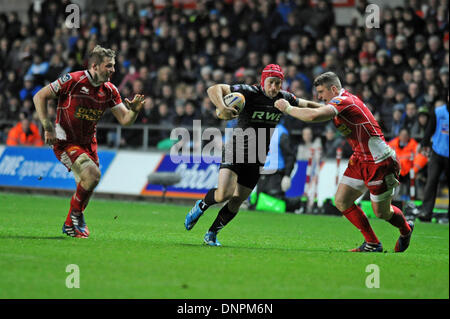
[335,183,383,252]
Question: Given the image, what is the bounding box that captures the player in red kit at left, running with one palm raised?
[33,45,144,238]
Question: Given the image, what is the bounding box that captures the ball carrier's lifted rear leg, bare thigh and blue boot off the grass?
[184,168,237,230]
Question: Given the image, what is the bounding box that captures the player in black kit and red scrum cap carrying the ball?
[184,64,312,246]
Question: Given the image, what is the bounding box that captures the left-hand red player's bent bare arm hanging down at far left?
[33,85,56,145]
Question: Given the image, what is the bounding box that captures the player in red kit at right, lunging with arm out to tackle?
[275,72,414,252]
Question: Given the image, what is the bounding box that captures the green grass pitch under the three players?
[0,193,449,299]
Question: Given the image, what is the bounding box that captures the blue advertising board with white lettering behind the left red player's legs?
[0,147,115,190]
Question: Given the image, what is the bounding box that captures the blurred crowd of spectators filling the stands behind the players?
[0,0,449,157]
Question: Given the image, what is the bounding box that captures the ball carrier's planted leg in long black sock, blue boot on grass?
[204,184,252,246]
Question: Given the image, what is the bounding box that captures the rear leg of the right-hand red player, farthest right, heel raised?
[372,196,414,252]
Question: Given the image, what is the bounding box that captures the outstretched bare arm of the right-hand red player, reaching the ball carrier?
[275,99,336,122]
